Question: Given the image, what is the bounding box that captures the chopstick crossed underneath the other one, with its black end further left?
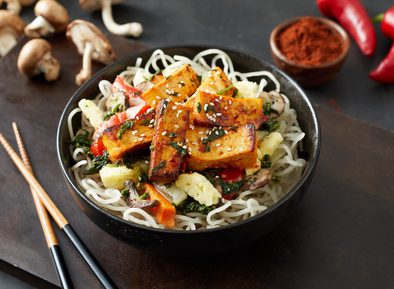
[12,122,74,289]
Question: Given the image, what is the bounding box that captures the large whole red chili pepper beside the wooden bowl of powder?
[316,0,377,56]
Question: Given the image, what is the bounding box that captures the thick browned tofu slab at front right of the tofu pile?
[184,124,257,171]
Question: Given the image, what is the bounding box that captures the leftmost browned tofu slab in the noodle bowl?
[102,112,155,161]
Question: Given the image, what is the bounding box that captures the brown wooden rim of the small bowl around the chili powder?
[270,15,350,69]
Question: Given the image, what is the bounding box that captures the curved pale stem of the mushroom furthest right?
[101,0,142,37]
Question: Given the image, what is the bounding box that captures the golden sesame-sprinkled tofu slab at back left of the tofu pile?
[142,64,200,108]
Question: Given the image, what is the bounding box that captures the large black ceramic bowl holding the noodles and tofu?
[57,46,321,256]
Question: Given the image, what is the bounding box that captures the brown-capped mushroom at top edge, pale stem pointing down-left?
[25,0,70,38]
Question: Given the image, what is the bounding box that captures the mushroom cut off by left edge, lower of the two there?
[0,10,25,56]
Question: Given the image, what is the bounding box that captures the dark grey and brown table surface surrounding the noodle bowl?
[0,0,394,289]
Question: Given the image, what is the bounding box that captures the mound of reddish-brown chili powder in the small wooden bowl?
[276,17,343,65]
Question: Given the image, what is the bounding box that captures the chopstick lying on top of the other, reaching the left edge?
[0,133,117,289]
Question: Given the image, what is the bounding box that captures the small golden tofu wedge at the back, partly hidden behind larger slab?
[197,67,235,97]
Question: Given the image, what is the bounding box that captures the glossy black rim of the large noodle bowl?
[56,44,321,235]
